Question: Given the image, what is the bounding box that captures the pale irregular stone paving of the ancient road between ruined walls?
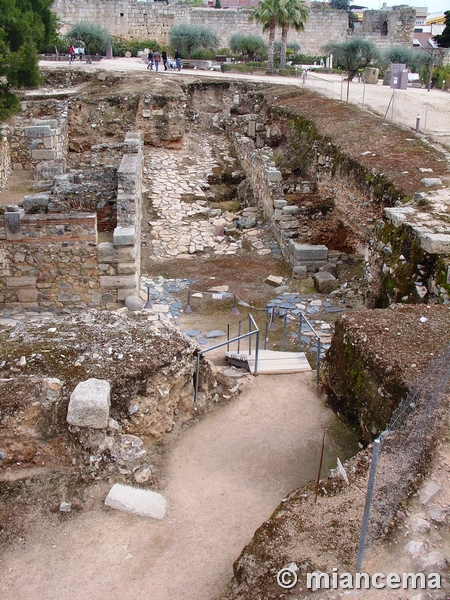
[144,136,277,261]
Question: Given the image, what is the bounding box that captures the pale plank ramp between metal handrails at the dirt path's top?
[225,350,311,375]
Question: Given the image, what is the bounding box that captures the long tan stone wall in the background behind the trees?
[53,0,415,55]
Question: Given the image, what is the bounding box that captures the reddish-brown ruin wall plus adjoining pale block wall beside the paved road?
[0,132,143,309]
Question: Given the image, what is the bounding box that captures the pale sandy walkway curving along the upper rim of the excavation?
[39,58,450,149]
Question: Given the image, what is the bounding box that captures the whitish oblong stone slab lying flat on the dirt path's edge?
[105,483,166,520]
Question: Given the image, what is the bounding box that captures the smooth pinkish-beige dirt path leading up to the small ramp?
[0,373,333,600]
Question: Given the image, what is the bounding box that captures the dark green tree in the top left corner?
[0,0,56,120]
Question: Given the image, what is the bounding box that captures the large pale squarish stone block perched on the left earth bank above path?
[67,378,111,429]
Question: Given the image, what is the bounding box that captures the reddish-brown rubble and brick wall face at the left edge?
[0,212,102,308]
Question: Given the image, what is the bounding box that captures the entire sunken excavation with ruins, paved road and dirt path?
[0,68,450,600]
